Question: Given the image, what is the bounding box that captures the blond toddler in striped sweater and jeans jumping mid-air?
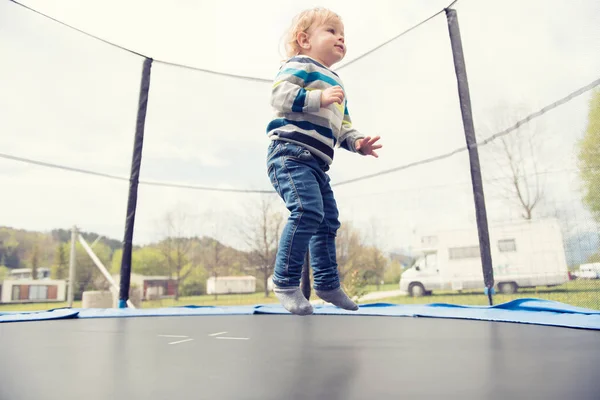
[267,8,381,315]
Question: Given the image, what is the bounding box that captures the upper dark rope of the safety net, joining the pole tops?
[8,0,458,83]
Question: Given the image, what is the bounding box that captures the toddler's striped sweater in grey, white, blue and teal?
[267,55,364,165]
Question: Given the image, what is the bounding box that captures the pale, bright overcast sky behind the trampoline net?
[0,0,600,253]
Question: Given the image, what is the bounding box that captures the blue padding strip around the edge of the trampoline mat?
[0,299,600,330]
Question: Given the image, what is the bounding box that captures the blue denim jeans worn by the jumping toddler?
[267,140,340,290]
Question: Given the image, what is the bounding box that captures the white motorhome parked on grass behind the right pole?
[400,219,569,296]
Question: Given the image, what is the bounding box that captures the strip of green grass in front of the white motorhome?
[368,280,600,310]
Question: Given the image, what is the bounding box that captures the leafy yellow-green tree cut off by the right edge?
[578,89,600,223]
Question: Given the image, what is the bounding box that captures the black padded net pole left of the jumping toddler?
[119,57,153,308]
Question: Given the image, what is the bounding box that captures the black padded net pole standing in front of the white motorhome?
[445,8,494,305]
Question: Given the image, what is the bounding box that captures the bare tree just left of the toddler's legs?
[242,195,283,297]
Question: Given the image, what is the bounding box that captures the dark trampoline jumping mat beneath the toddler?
[0,315,600,400]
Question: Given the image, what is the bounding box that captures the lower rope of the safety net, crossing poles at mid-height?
[0,78,600,194]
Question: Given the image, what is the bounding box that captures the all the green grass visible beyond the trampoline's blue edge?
[0,280,600,312]
